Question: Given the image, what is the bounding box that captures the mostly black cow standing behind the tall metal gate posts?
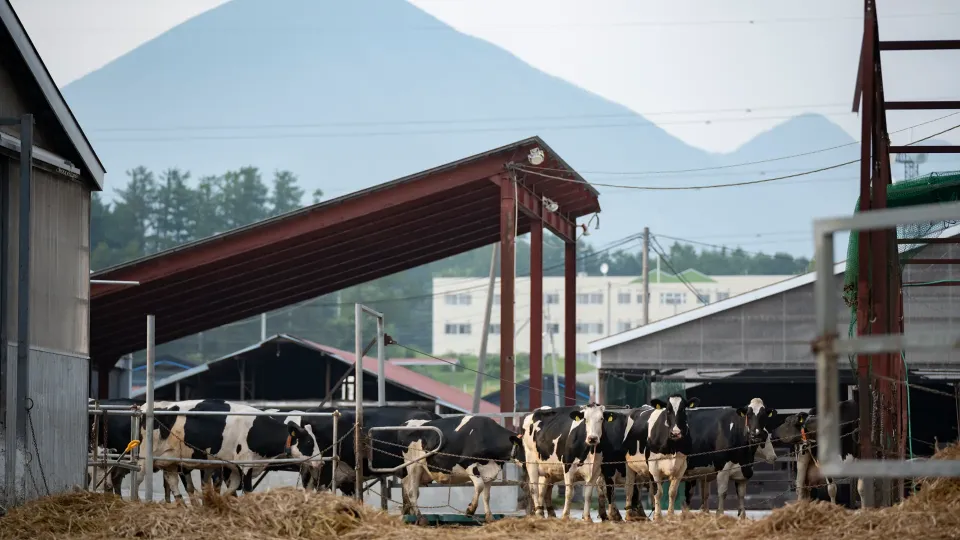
[301,407,440,496]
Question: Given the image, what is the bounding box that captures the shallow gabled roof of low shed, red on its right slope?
[130,334,500,413]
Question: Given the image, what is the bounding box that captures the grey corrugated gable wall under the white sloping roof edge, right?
[602,240,960,369]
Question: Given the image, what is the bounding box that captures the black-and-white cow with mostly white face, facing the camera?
[522,403,618,521]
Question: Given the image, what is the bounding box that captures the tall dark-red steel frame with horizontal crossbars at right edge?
[853,0,960,502]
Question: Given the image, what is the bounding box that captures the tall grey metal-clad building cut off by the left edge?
[0,0,104,508]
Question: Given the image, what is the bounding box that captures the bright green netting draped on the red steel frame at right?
[843,171,960,322]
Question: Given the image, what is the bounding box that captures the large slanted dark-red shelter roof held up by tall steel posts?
[90,137,600,365]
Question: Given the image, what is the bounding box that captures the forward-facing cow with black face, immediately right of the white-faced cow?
[625,394,700,519]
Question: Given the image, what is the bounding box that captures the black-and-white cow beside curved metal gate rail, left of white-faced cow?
[398,415,523,521]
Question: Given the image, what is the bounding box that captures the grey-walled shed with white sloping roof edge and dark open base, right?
[590,225,960,455]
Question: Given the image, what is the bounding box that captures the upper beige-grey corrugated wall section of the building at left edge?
[8,167,90,356]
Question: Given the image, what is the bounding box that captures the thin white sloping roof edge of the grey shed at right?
[589,221,960,353]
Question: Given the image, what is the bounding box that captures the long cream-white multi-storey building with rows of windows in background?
[433,269,793,361]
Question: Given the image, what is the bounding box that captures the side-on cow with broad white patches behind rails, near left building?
[140,399,315,501]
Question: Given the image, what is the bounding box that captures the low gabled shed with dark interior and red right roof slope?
[130,334,499,414]
